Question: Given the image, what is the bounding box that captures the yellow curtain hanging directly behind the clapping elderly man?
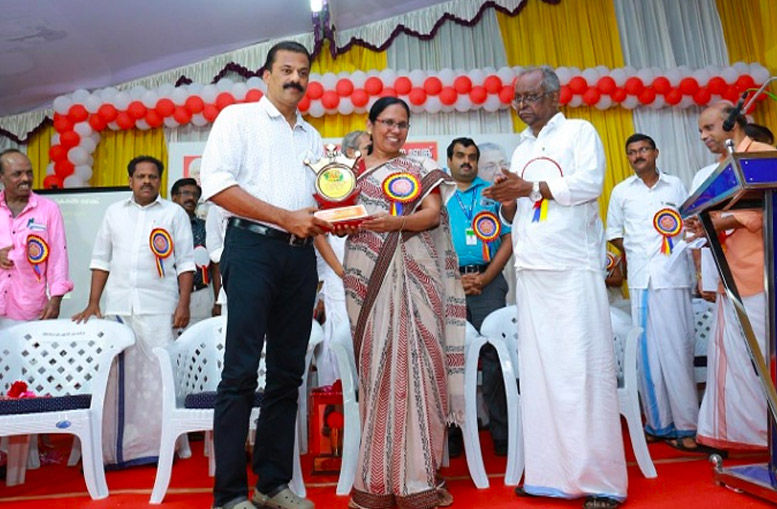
[497,0,634,218]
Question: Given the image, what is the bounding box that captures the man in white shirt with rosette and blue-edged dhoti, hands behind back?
[607,134,706,452]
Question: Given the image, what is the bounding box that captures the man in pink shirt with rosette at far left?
[0,149,73,330]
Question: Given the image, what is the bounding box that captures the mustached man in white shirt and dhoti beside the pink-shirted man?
[73,156,194,467]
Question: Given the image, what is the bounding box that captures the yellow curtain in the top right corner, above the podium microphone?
[717,0,777,133]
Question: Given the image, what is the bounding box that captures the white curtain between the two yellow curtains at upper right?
[615,0,729,187]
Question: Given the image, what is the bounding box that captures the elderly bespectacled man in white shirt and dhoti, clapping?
[483,66,627,508]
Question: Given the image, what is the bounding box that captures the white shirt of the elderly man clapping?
[510,113,605,272]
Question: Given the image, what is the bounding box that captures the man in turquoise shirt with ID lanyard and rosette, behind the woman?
[446,138,513,456]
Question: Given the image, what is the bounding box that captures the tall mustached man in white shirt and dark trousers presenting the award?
[200,41,331,509]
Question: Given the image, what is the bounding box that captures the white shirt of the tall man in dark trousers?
[200,96,323,228]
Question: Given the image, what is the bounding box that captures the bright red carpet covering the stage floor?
[0,424,771,509]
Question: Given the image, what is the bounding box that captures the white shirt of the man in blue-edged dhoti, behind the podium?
[607,171,693,289]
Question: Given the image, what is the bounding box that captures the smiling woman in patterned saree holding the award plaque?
[344,97,466,509]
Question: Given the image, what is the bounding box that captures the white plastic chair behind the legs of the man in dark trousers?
[151,316,322,504]
